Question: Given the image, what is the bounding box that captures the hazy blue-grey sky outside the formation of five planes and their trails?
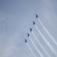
[0,0,57,57]
